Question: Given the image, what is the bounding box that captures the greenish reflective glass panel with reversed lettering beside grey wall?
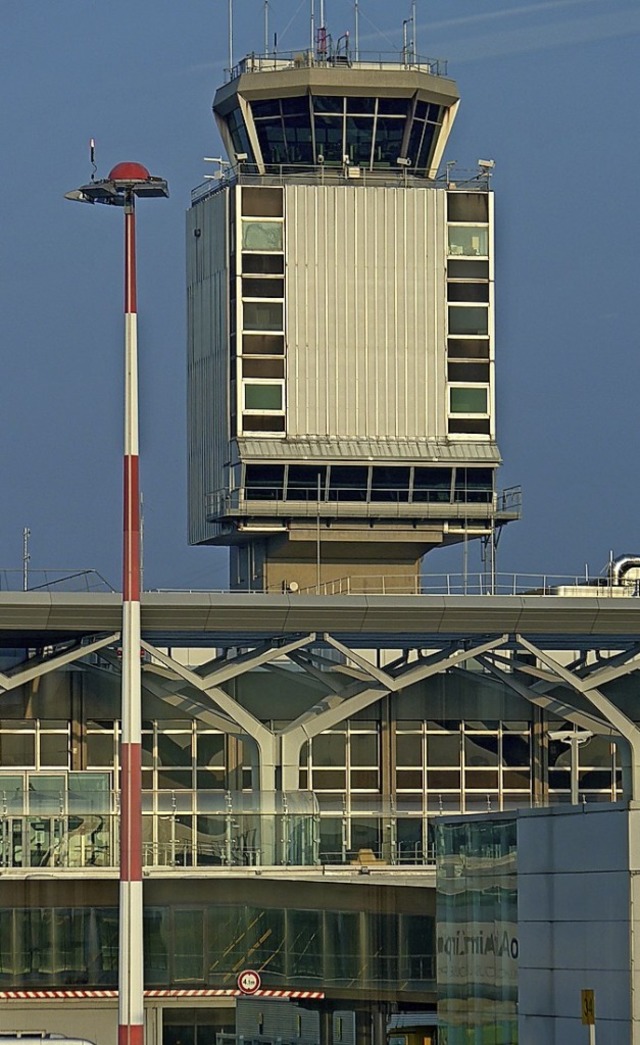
[435,818,519,1045]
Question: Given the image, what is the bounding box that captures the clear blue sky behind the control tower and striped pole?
[0,0,640,588]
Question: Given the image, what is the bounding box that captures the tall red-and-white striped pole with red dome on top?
[67,163,168,1045]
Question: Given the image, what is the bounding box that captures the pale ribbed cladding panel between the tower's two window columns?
[285,185,447,439]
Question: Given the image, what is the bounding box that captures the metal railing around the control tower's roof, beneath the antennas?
[228,47,447,80]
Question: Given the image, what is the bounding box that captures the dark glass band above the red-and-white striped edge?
[0,903,435,999]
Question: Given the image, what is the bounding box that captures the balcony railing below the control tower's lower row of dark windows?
[206,483,522,520]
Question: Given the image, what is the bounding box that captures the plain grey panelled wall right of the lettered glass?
[518,806,640,1045]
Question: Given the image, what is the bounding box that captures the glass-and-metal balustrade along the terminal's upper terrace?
[0,781,434,876]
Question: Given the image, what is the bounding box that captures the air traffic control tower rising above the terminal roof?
[187,29,519,593]
